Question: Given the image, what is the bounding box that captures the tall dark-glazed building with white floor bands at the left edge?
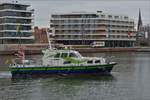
[0,1,34,44]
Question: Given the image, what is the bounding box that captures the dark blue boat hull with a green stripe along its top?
[10,63,116,76]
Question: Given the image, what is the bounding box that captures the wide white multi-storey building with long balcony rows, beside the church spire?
[50,11,136,47]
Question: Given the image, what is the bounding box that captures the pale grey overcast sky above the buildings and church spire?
[1,0,150,27]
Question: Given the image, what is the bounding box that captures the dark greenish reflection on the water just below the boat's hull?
[11,74,116,84]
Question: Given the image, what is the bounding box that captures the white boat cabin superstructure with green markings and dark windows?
[42,49,108,66]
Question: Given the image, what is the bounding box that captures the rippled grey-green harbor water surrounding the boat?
[0,52,150,100]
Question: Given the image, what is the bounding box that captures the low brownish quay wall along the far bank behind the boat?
[0,44,150,55]
